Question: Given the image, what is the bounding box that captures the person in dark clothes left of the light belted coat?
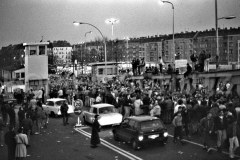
[4,126,16,160]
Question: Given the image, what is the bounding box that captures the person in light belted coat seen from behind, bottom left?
[15,128,28,160]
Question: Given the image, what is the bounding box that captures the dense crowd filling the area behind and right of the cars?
[73,76,240,158]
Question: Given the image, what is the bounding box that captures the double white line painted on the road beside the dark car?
[74,128,143,160]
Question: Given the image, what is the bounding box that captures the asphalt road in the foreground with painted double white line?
[0,107,240,160]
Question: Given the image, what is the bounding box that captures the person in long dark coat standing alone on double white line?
[91,115,101,148]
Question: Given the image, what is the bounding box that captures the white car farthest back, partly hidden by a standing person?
[42,98,74,117]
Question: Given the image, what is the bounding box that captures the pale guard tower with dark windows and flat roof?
[23,42,49,94]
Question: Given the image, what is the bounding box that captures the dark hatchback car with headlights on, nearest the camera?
[112,116,168,150]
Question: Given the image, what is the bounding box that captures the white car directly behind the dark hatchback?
[83,103,123,126]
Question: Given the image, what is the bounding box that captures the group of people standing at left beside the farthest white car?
[0,93,49,160]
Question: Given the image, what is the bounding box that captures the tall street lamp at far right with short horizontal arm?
[215,0,236,70]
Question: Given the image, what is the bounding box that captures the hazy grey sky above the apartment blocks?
[0,0,240,47]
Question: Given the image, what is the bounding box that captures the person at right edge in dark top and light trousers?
[227,119,240,158]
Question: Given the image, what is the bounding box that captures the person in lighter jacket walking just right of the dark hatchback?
[172,111,184,144]
